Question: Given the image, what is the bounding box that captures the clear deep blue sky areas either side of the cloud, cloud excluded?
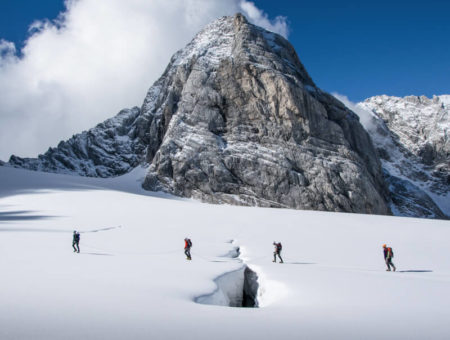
[0,0,450,101]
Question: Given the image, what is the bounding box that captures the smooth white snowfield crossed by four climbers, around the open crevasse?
[0,167,450,339]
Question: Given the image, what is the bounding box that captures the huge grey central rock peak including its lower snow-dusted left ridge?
[9,14,390,214]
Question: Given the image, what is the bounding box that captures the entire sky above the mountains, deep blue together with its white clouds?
[0,0,450,160]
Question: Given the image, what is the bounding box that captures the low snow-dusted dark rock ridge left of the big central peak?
[8,107,146,177]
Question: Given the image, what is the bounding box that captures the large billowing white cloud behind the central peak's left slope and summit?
[0,0,288,160]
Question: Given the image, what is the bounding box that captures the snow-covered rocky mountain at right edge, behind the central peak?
[358,95,450,218]
